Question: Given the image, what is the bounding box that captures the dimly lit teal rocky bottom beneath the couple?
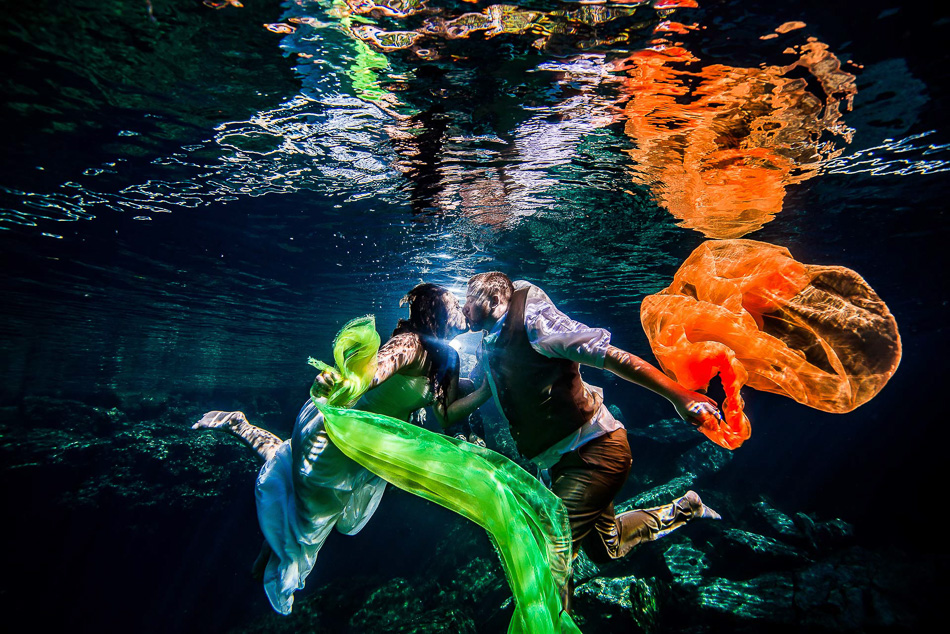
[0,395,947,634]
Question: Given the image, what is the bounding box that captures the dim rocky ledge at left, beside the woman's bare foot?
[0,397,268,510]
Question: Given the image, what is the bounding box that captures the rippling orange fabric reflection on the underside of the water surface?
[616,40,856,238]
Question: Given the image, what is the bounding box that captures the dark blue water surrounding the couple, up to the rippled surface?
[0,0,950,632]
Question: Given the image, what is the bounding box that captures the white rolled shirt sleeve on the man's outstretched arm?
[515,280,610,369]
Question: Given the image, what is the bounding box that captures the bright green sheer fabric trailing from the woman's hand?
[314,318,580,634]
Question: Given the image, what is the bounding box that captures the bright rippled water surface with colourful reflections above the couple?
[0,0,945,237]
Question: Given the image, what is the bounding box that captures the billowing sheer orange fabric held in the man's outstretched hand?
[640,240,901,449]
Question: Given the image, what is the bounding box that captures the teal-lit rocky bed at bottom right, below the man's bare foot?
[575,494,945,634]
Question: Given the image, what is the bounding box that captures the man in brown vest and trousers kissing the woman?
[457,271,722,563]
